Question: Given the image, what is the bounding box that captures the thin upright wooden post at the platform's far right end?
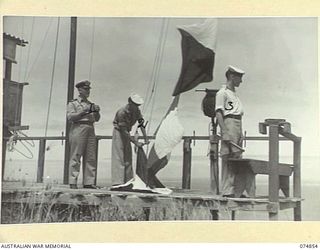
[293,140,302,221]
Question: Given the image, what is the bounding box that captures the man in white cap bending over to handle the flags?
[111,94,148,185]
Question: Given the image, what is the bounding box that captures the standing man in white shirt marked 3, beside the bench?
[216,65,255,197]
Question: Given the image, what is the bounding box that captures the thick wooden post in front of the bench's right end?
[269,124,279,220]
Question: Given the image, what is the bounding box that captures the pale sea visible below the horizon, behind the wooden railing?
[4,157,320,221]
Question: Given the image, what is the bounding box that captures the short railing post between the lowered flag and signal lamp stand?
[182,138,192,189]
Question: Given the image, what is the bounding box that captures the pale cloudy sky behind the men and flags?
[3,16,320,178]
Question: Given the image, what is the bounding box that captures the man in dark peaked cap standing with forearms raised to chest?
[67,81,100,189]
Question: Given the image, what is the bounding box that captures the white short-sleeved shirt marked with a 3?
[216,85,243,116]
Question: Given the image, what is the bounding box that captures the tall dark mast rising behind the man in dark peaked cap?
[63,17,77,184]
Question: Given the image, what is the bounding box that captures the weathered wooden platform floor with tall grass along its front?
[1,182,302,223]
